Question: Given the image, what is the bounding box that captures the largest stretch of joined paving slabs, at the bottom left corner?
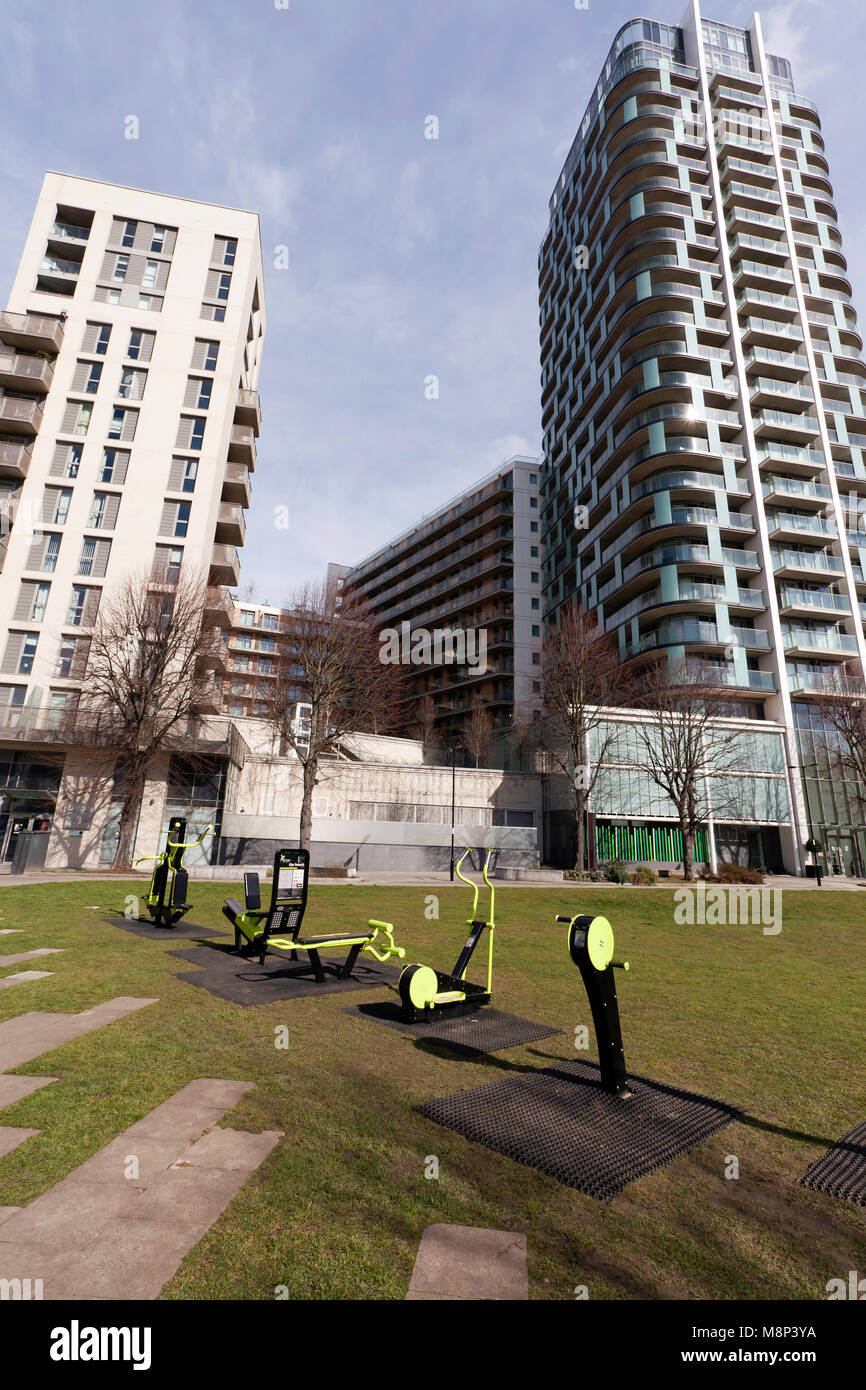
[0,1079,282,1300]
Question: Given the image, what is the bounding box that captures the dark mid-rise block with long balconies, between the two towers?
[339,457,541,745]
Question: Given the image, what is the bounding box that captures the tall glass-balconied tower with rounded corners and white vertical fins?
[538,0,866,873]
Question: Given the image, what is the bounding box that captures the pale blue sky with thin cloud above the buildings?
[0,0,866,603]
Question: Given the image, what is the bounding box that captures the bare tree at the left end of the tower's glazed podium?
[542,599,631,870]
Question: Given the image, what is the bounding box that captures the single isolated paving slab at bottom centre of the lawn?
[406,1223,530,1301]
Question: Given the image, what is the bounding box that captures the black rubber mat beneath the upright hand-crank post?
[418,1061,742,1201]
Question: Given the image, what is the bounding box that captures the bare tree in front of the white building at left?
[79,573,221,869]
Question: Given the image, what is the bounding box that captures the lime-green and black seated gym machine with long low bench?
[222,849,406,984]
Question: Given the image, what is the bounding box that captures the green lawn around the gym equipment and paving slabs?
[0,880,866,1300]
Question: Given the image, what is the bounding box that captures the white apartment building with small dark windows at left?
[0,172,265,859]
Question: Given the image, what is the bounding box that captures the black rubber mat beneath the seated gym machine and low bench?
[168,942,400,1005]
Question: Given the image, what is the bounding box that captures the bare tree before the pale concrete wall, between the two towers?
[265,582,405,849]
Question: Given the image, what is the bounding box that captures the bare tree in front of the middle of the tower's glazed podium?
[634,657,741,880]
